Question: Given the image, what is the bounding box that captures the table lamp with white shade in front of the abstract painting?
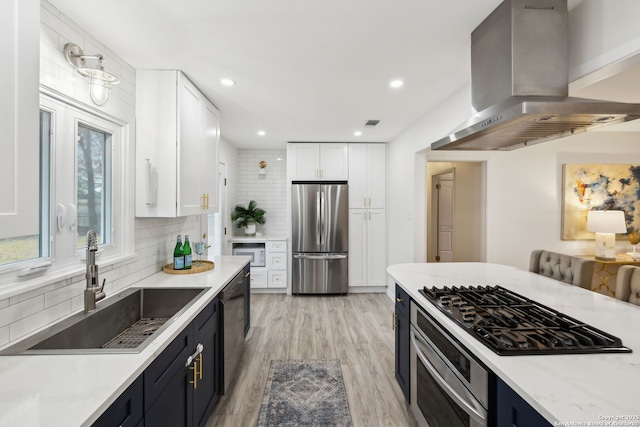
[587,211,627,261]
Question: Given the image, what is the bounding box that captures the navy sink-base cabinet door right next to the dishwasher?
[193,298,220,427]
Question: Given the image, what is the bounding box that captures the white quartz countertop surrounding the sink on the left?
[0,256,249,427]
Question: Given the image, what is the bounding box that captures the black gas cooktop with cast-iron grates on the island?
[420,286,631,356]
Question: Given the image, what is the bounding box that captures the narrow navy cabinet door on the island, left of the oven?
[393,284,410,401]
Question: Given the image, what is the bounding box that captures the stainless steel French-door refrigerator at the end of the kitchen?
[291,182,349,294]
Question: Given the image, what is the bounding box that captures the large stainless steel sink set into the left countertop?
[0,288,206,355]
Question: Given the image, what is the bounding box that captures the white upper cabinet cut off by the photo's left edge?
[0,0,40,239]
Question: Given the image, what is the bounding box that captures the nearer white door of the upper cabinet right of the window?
[177,73,203,216]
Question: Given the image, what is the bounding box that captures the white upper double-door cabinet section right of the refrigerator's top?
[349,144,386,209]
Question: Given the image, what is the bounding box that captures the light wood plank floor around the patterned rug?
[207,294,417,427]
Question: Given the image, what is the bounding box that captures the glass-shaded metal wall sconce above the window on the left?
[64,43,120,107]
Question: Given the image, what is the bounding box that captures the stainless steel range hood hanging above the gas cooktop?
[431,0,640,150]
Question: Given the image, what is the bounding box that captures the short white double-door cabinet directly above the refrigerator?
[287,143,349,181]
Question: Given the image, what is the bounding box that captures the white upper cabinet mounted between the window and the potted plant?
[136,70,220,217]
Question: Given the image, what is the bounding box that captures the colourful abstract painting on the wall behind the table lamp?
[562,164,640,240]
